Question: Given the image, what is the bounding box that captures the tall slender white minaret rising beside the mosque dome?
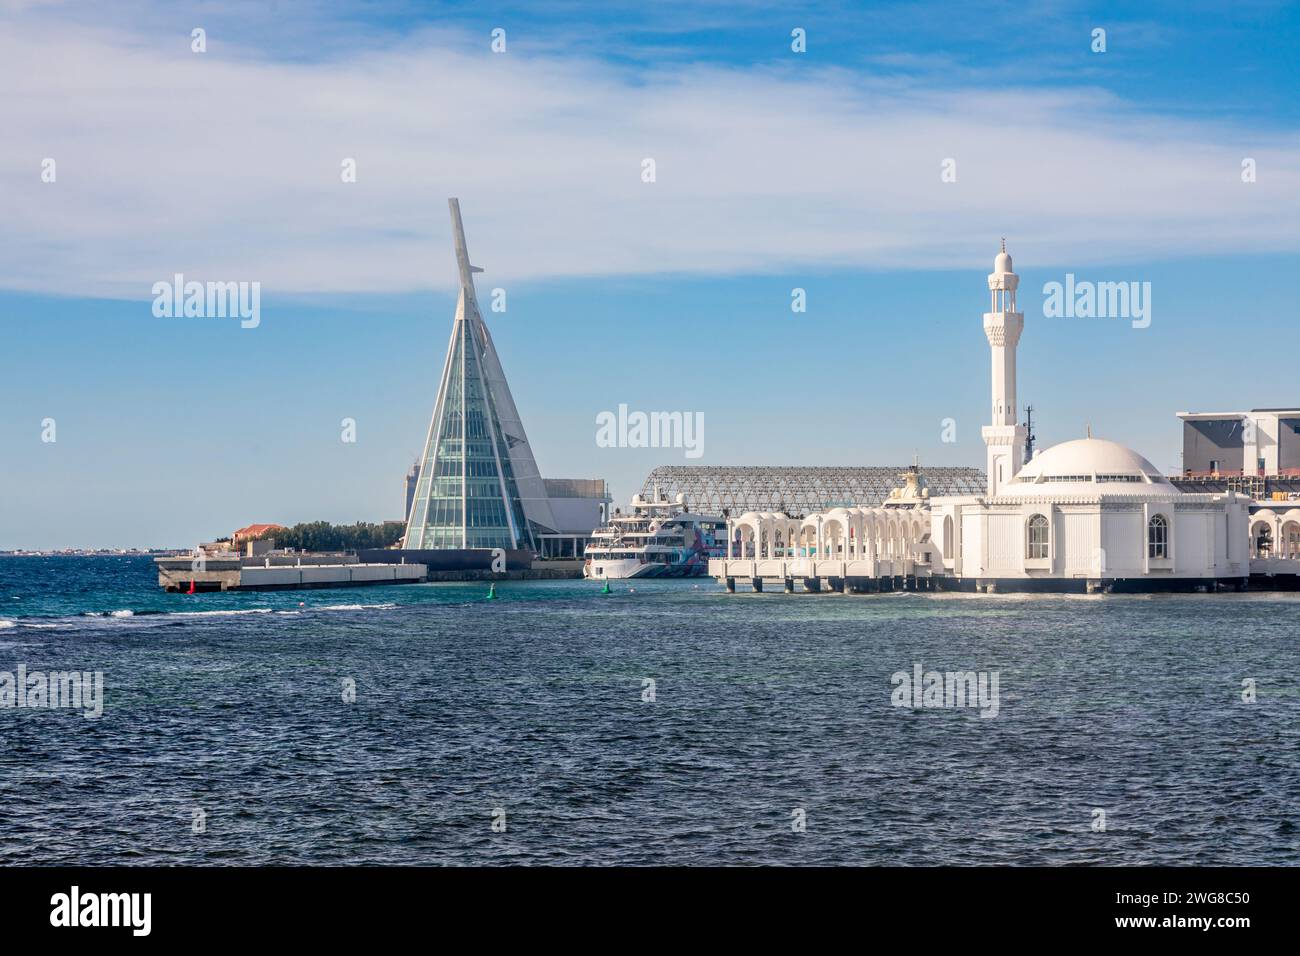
[983,239,1026,496]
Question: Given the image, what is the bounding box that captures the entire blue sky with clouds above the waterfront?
[0,0,1300,549]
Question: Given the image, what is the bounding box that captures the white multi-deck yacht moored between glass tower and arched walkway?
[582,485,727,579]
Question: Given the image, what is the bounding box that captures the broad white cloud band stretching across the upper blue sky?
[0,5,1300,298]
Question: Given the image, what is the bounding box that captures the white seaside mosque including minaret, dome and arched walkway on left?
[710,245,1251,592]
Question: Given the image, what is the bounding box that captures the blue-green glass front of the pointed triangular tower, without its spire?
[404,302,534,548]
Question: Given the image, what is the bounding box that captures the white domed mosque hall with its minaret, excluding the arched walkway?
[930,246,1251,591]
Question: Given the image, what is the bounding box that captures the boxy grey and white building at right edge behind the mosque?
[1178,408,1300,477]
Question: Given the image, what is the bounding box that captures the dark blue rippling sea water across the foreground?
[0,558,1300,865]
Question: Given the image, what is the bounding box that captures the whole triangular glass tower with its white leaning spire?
[402,199,555,549]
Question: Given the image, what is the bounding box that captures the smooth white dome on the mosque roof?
[1004,438,1179,497]
